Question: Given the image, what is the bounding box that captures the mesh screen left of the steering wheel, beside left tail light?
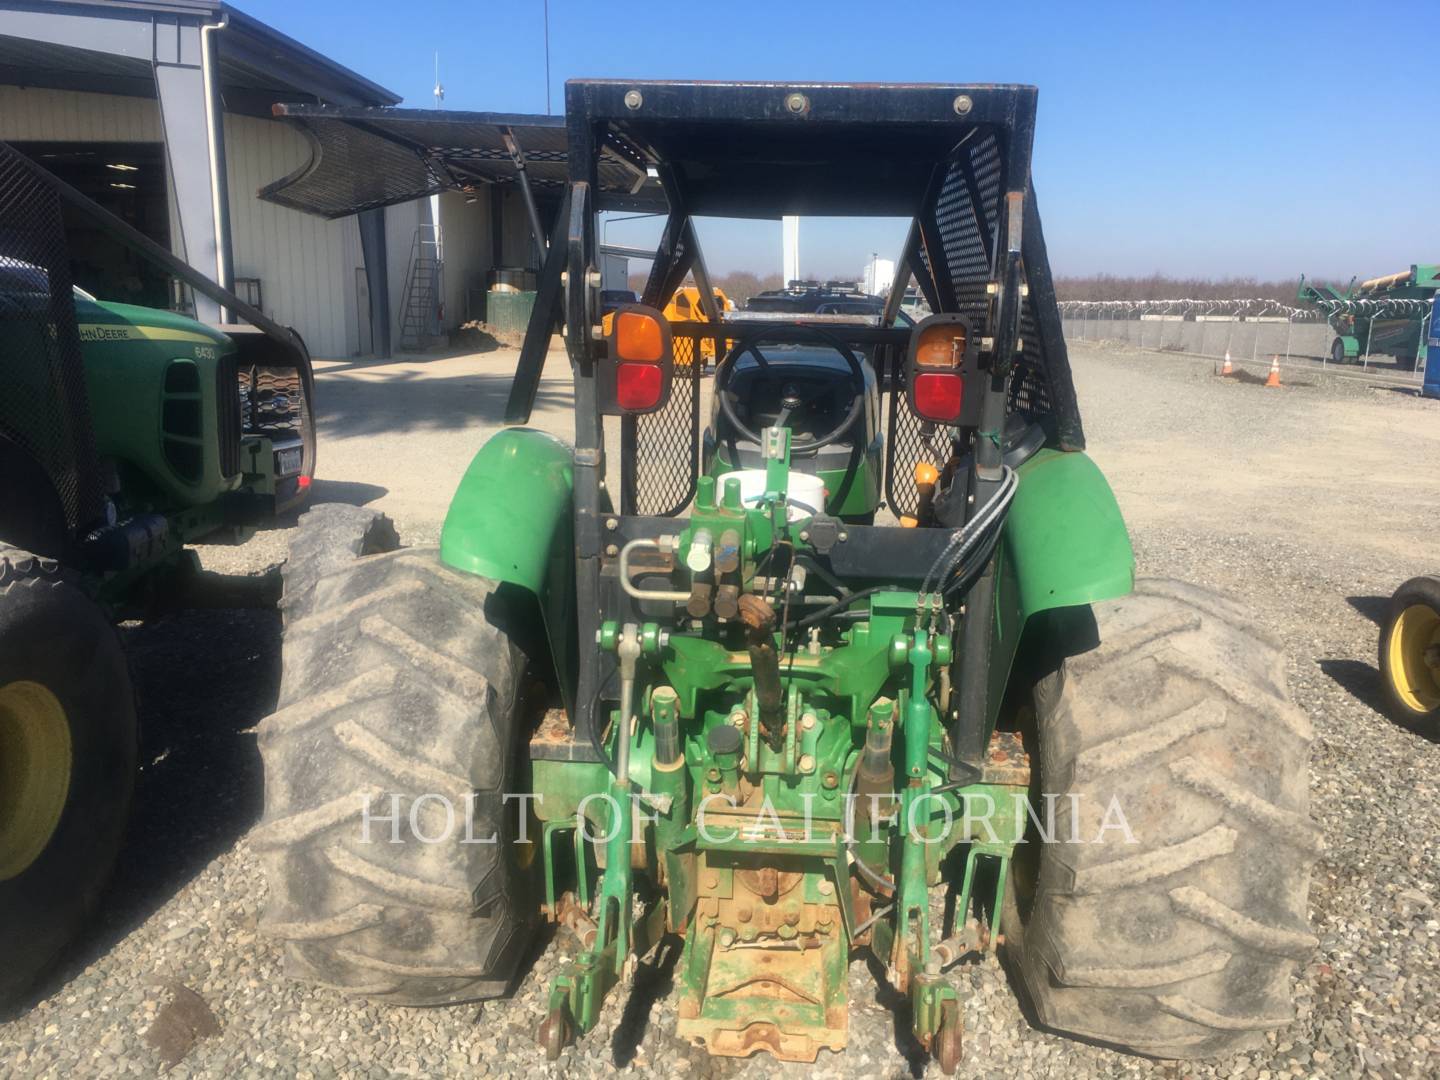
[622,336,702,517]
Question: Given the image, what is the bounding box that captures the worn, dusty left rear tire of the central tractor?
[251,505,543,1005]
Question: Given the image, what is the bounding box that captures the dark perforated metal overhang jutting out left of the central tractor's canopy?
[259,104,667,217]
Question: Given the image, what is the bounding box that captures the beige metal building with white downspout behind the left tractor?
[0,0,534,357]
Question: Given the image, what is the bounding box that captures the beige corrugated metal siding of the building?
[0,86,428,357]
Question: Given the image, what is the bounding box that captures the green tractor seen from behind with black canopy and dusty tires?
[252,81,1319,1070]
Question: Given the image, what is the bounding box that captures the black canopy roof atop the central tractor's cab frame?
[566,79,1035,217]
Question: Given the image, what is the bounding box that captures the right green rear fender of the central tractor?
[988,449,1135,724]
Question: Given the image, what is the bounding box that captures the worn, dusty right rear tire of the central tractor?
[1004,580,1320,1058]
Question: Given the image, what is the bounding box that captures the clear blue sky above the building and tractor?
[238,0,1440,278]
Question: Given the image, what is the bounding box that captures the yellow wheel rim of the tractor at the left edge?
[0,680,72,881]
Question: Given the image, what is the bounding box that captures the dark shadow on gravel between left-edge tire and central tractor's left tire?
[14,609,281,1015]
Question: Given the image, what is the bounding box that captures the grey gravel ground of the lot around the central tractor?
[0,346,1440,1080]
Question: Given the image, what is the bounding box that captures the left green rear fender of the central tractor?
[441,428,576,697]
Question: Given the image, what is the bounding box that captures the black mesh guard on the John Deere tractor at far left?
[0,143,101,531]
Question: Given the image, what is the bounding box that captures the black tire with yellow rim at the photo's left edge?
[0,546,138,1007]
